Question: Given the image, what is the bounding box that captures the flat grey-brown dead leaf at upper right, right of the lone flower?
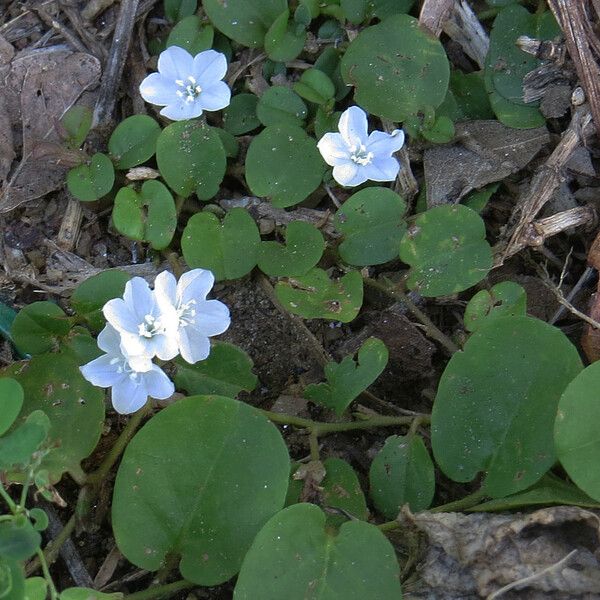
[423,121,550,208]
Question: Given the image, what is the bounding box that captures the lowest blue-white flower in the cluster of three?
[80,325,175,414]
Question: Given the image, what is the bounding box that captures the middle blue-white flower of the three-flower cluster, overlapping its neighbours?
[102,277,179,371]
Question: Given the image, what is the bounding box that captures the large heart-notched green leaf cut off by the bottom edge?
[233,504,402,600]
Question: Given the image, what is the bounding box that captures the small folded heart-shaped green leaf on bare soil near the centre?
[304,338,389,415]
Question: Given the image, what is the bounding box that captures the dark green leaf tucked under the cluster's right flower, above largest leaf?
[174,342,258,398]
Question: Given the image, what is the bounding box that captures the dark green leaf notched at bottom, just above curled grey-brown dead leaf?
[369,435,435,519]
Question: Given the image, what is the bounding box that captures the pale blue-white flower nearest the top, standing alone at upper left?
[140,46,231,121]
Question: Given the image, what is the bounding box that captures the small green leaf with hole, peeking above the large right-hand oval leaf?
[465,281,527,331]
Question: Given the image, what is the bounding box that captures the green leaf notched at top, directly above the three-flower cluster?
[181,208,260,280]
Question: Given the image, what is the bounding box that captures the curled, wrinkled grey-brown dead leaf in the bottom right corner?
[405,506,600,600]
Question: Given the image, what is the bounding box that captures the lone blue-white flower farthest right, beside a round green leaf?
[317,106,404,187]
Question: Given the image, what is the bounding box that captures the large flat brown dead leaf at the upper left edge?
[0,46,100,213]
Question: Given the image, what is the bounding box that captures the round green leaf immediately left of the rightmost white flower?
[246,124,325,208]
